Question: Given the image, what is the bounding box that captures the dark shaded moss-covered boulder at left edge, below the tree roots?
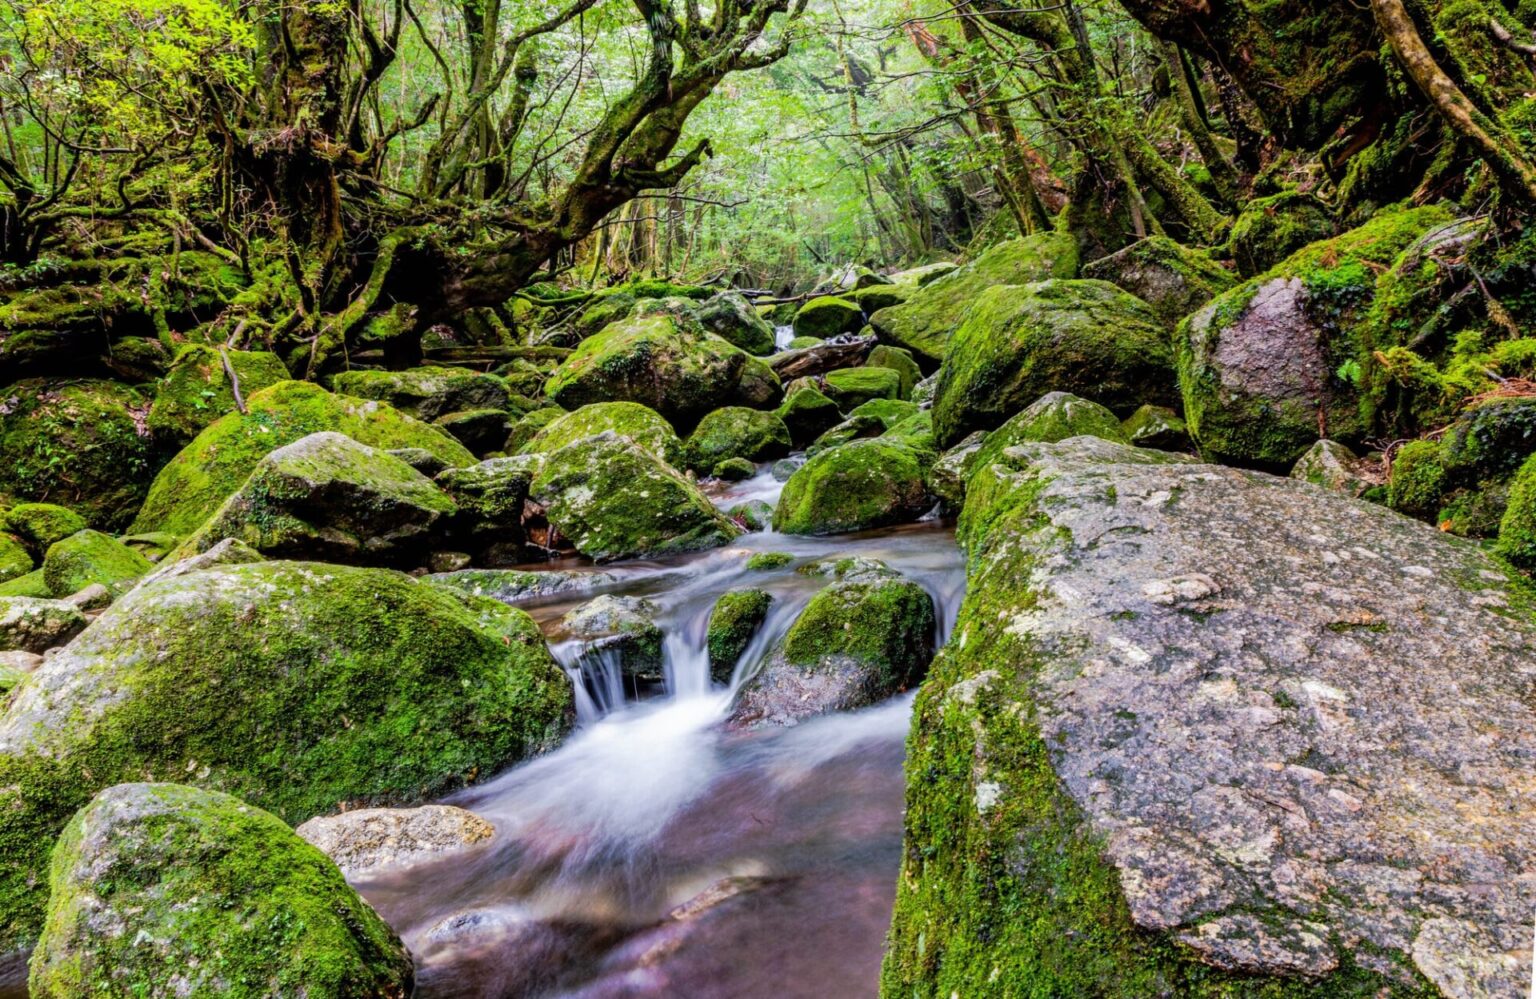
[0,378,158,530]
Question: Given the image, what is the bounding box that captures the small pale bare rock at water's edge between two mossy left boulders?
[293,805,496,878]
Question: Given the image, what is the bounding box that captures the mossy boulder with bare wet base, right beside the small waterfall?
[731,559,934,727]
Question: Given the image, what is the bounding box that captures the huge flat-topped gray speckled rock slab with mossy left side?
[885,438,1536,997]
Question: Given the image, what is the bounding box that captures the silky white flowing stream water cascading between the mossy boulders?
[356,475,965,999]
